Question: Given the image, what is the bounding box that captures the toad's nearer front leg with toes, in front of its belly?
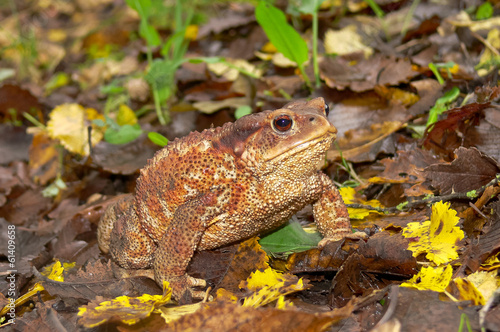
[153,189,228,303]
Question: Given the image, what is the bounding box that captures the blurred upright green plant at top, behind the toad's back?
[126,0,193,125]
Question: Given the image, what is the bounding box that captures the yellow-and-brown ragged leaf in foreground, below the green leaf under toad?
[240,267,309,308]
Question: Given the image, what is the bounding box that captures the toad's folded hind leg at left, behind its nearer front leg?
[109,204,156,269]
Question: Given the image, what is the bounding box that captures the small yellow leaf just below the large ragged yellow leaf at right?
[401,265,453,292]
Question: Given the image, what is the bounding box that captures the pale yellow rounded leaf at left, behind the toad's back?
[47,104,104,156]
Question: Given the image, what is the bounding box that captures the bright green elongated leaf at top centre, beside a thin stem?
[255,1,308,66]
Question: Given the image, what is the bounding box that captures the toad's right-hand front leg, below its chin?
[313,172,366,247]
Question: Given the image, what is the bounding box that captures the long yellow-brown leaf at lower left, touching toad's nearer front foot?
[78,281,172,328]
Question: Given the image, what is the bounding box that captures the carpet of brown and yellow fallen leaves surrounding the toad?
[0,0,500,331]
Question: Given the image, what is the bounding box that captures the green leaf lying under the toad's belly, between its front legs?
[259,221,321,253]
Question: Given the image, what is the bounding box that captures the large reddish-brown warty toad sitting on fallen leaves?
[98,98,351,302]
